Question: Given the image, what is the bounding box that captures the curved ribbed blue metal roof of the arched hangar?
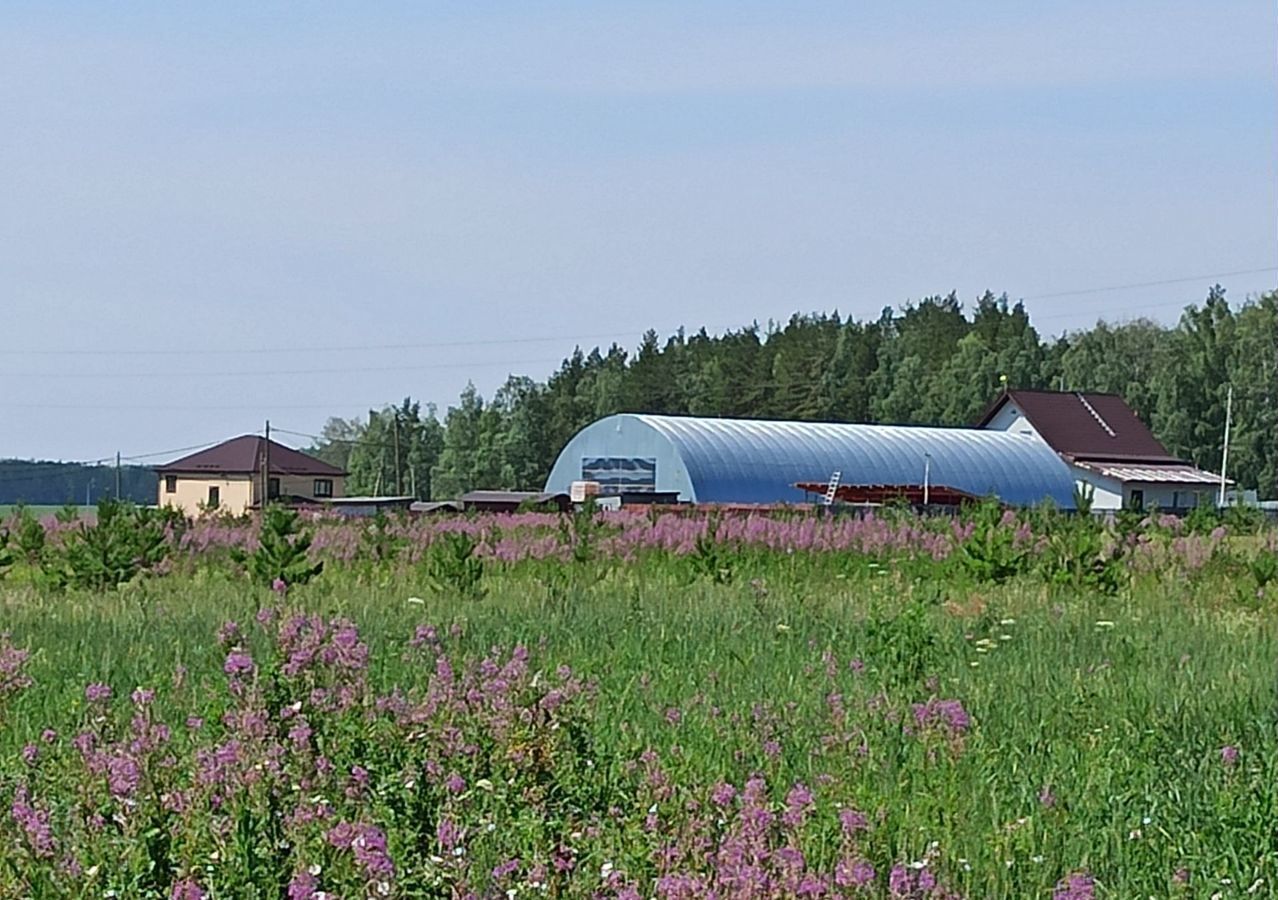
[544,414,1074,508]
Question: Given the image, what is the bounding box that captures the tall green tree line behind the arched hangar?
[309,286,1278,499]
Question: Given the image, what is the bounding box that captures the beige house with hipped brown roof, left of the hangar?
[156,435,346,516]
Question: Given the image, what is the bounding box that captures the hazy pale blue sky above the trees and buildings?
[0,0,1278,462]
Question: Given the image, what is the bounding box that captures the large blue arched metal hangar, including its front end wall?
[546,413,1074,509]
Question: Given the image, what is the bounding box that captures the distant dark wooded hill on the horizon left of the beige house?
[0,459,157,505]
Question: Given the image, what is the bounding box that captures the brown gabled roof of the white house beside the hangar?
[976,391,1180,463]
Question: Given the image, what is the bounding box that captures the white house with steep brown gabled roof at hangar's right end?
[976,390,1220,510]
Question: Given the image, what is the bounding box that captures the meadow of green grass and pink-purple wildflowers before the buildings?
[0,509,1278,900]
